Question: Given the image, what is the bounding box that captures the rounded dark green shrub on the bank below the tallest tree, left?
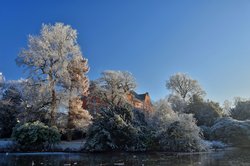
[12,121,61,150]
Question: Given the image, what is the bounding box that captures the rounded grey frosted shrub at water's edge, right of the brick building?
[156,114,206,152]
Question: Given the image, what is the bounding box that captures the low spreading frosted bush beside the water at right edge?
[210,118,250,147]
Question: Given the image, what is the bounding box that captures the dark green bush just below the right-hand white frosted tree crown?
[186,96,223,126]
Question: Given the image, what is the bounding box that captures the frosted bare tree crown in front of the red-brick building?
[88,70,136,110]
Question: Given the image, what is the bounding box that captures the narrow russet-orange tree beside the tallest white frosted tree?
[67,58,91,132]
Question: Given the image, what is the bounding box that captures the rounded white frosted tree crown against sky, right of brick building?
[166,73,205,101]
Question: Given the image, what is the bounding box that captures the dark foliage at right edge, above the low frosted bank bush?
[231,100,250,120]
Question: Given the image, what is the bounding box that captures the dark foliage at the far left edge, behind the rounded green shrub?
[0,87,23,138]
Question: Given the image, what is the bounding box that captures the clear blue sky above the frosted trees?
[0,0,250,102]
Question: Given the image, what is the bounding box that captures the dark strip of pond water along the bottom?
[0,149,250,166]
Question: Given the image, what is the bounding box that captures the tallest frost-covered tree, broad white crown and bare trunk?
[16,23,85,125]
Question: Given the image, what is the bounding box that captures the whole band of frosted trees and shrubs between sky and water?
[0,23,250,152]
